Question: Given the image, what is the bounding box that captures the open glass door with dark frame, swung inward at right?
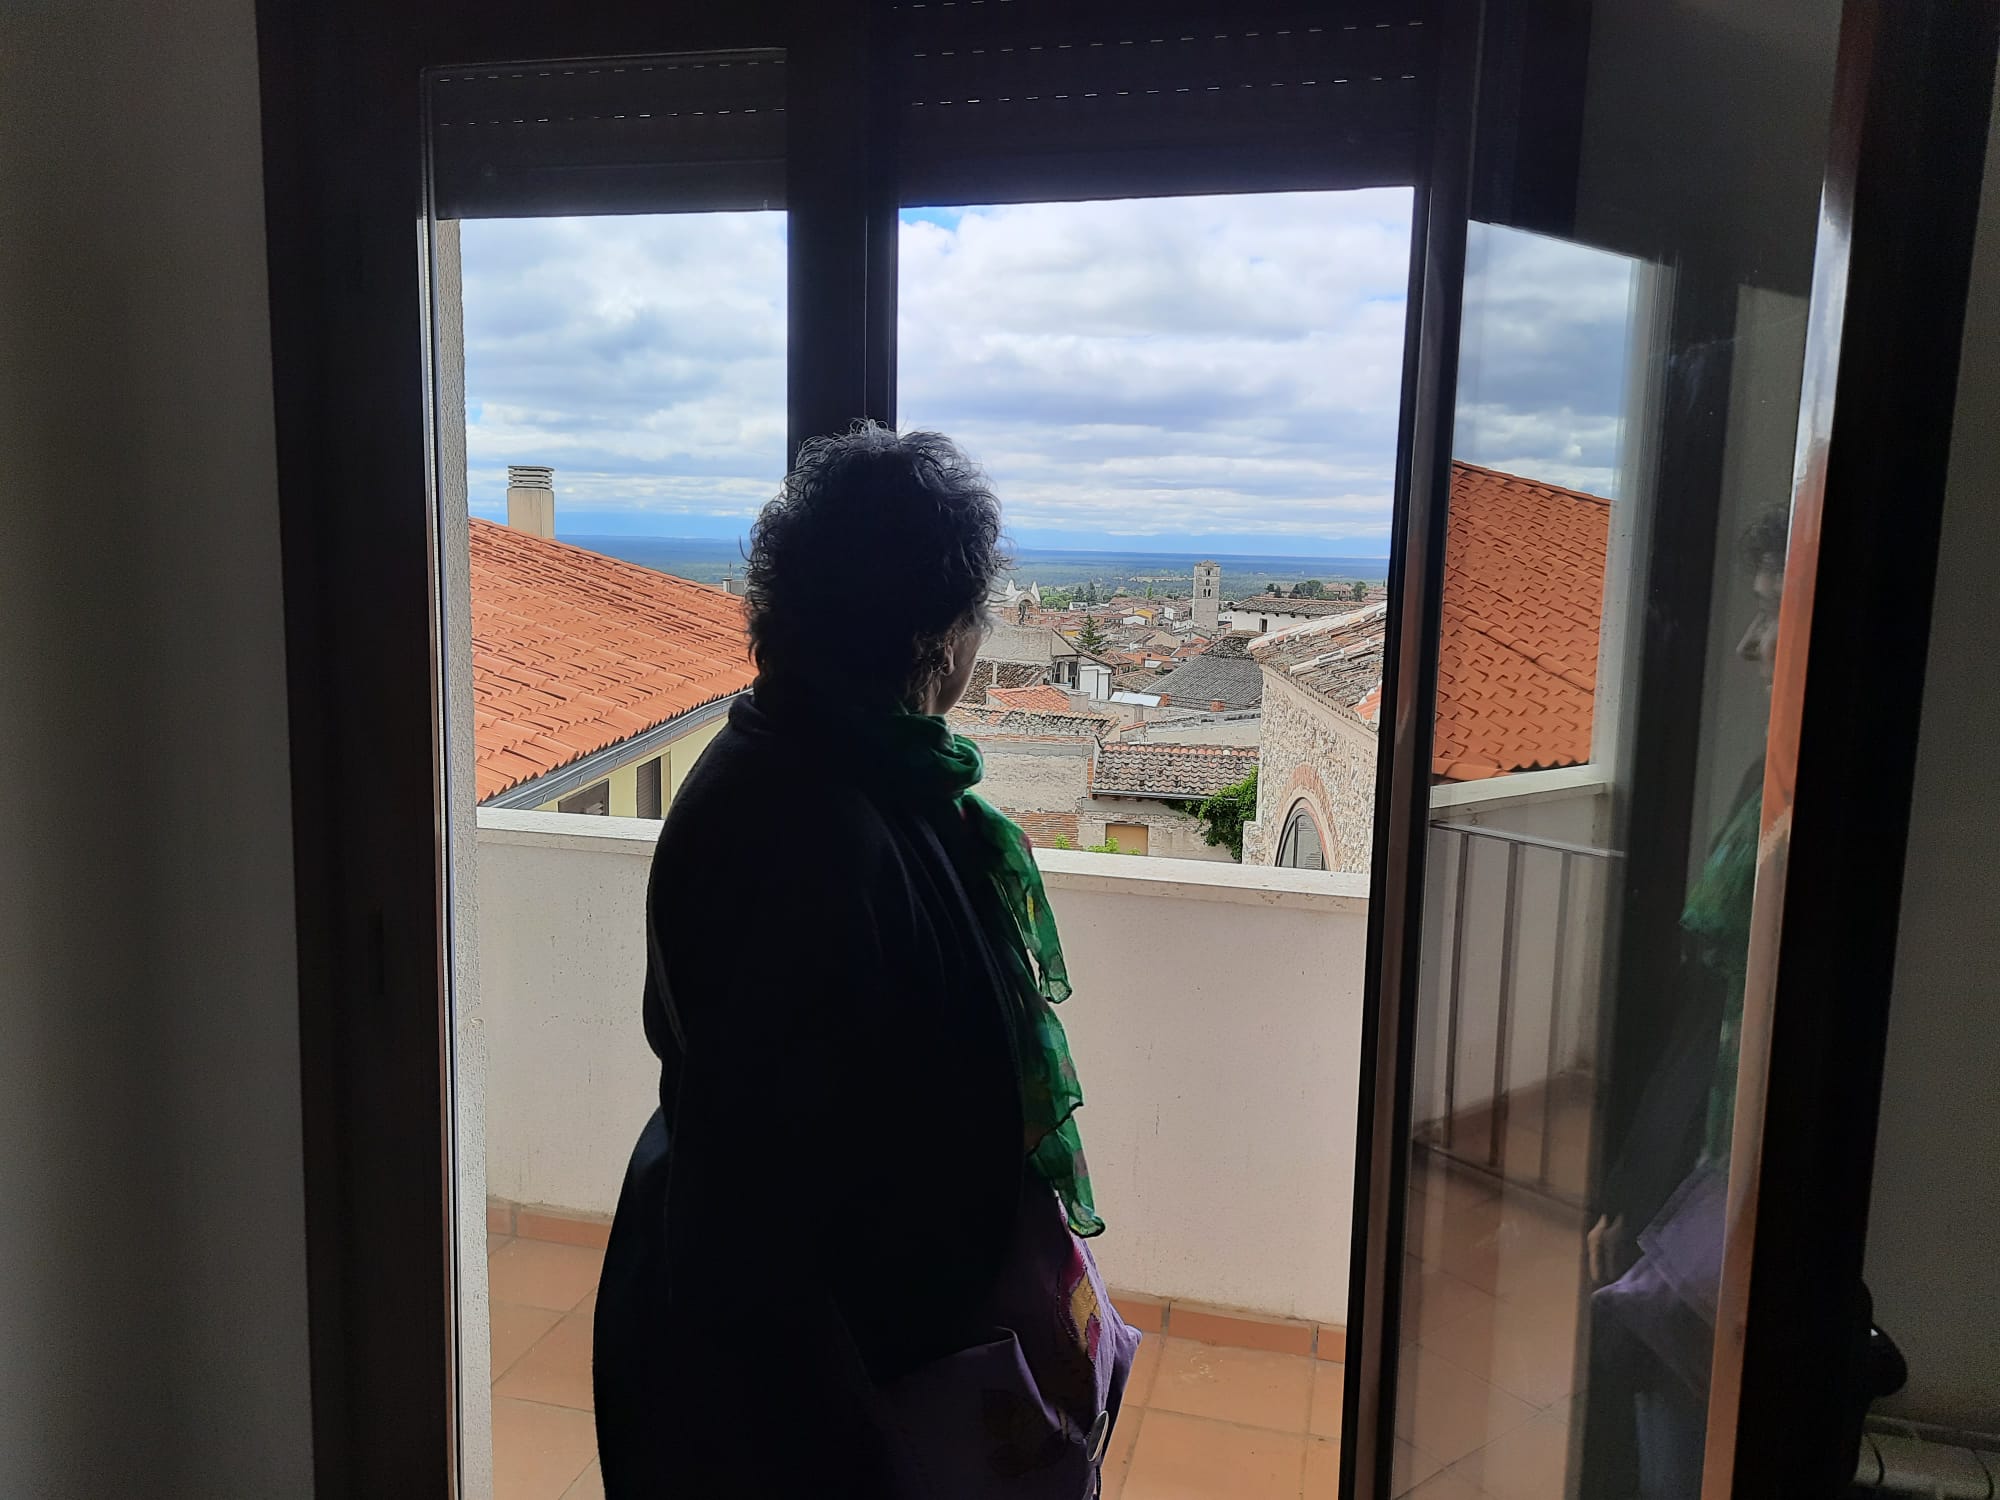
[1348,4,2000,1500]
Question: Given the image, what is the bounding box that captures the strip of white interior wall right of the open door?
[1868,64,2000,1434]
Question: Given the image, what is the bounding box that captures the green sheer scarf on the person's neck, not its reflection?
[862,710,1104,1238]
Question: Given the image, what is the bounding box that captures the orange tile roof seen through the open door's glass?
[1432,462,1612,780]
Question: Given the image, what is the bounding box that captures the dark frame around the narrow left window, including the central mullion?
[258,0,1456,1494]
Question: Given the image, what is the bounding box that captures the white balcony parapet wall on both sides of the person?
[476,810,1368,1324]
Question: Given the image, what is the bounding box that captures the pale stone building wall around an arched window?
[1244,668,1376,872]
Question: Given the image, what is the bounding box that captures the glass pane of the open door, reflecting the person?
[1392,6,1838,1500]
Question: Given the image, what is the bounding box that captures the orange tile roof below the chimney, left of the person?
[472,516,756,802]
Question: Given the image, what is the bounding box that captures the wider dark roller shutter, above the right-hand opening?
[888,0,1436,204]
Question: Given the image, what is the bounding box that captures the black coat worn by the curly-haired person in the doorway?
[594,684,1024,1500]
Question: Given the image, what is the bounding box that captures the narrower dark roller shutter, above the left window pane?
[424,48,784,218]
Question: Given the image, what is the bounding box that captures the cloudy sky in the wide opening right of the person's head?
[898,188,1410,542]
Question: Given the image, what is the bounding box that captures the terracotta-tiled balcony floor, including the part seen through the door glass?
[488,1172,1578,1500]
